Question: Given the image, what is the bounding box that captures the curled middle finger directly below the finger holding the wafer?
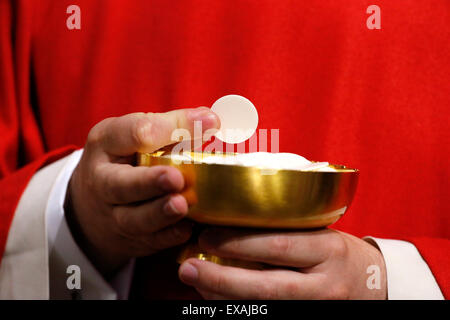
[94,163,184,204]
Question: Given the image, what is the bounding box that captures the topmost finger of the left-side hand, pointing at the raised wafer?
[88,107,220,156]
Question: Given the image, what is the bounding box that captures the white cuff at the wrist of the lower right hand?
[364,237,444,300]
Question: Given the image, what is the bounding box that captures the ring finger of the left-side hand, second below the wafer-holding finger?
[112,194,188,236]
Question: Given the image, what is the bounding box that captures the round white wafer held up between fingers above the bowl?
[211,94,258,143]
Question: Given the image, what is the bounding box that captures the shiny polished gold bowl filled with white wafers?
[137,151,359,264]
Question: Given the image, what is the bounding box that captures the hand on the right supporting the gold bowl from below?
[179,227,387,300]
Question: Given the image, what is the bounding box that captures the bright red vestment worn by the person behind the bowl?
[0,0,450,298]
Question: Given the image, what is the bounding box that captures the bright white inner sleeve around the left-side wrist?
[45,150,134,300]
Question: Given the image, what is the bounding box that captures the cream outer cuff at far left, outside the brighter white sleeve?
[0,154,67,300]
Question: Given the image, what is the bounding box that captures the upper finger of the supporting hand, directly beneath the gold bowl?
[199,228,342,268]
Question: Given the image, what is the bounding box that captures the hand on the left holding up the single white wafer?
[66,107,220,277]
